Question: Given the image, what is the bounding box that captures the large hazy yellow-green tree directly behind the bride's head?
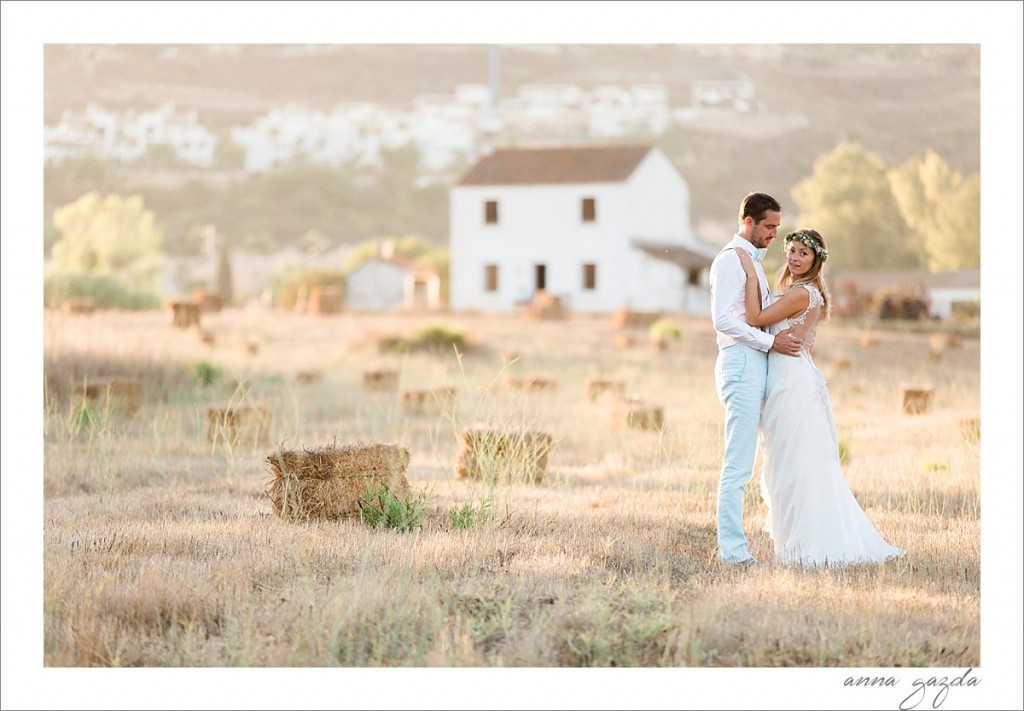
[793,141,923,269]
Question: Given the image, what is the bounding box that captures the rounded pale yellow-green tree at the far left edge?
[52,192,163,292]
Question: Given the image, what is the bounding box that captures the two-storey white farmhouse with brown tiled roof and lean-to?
[450,145,717,316]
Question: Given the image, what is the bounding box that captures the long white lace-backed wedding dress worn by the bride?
[760,284,905,566]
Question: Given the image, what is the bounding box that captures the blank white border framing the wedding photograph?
[0,0,1024,709]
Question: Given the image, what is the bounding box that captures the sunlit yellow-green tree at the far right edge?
[889,150,981,271]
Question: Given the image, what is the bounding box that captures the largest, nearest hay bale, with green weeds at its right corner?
[265,445,410,519]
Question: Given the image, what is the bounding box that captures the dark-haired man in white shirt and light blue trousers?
[709,193,801,566]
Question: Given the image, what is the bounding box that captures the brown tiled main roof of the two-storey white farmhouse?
[457,145,652,185]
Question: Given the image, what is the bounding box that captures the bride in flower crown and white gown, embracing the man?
[736,229,906,566]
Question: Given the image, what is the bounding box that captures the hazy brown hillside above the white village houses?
[44,45,980,237]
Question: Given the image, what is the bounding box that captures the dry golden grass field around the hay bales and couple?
[43,308,981,684]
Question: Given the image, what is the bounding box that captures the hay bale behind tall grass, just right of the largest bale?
[456,427,554,484]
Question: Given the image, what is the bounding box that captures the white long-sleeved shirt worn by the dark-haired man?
[708,235,775,351]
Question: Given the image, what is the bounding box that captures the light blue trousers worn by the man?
[715,343,768,562]
